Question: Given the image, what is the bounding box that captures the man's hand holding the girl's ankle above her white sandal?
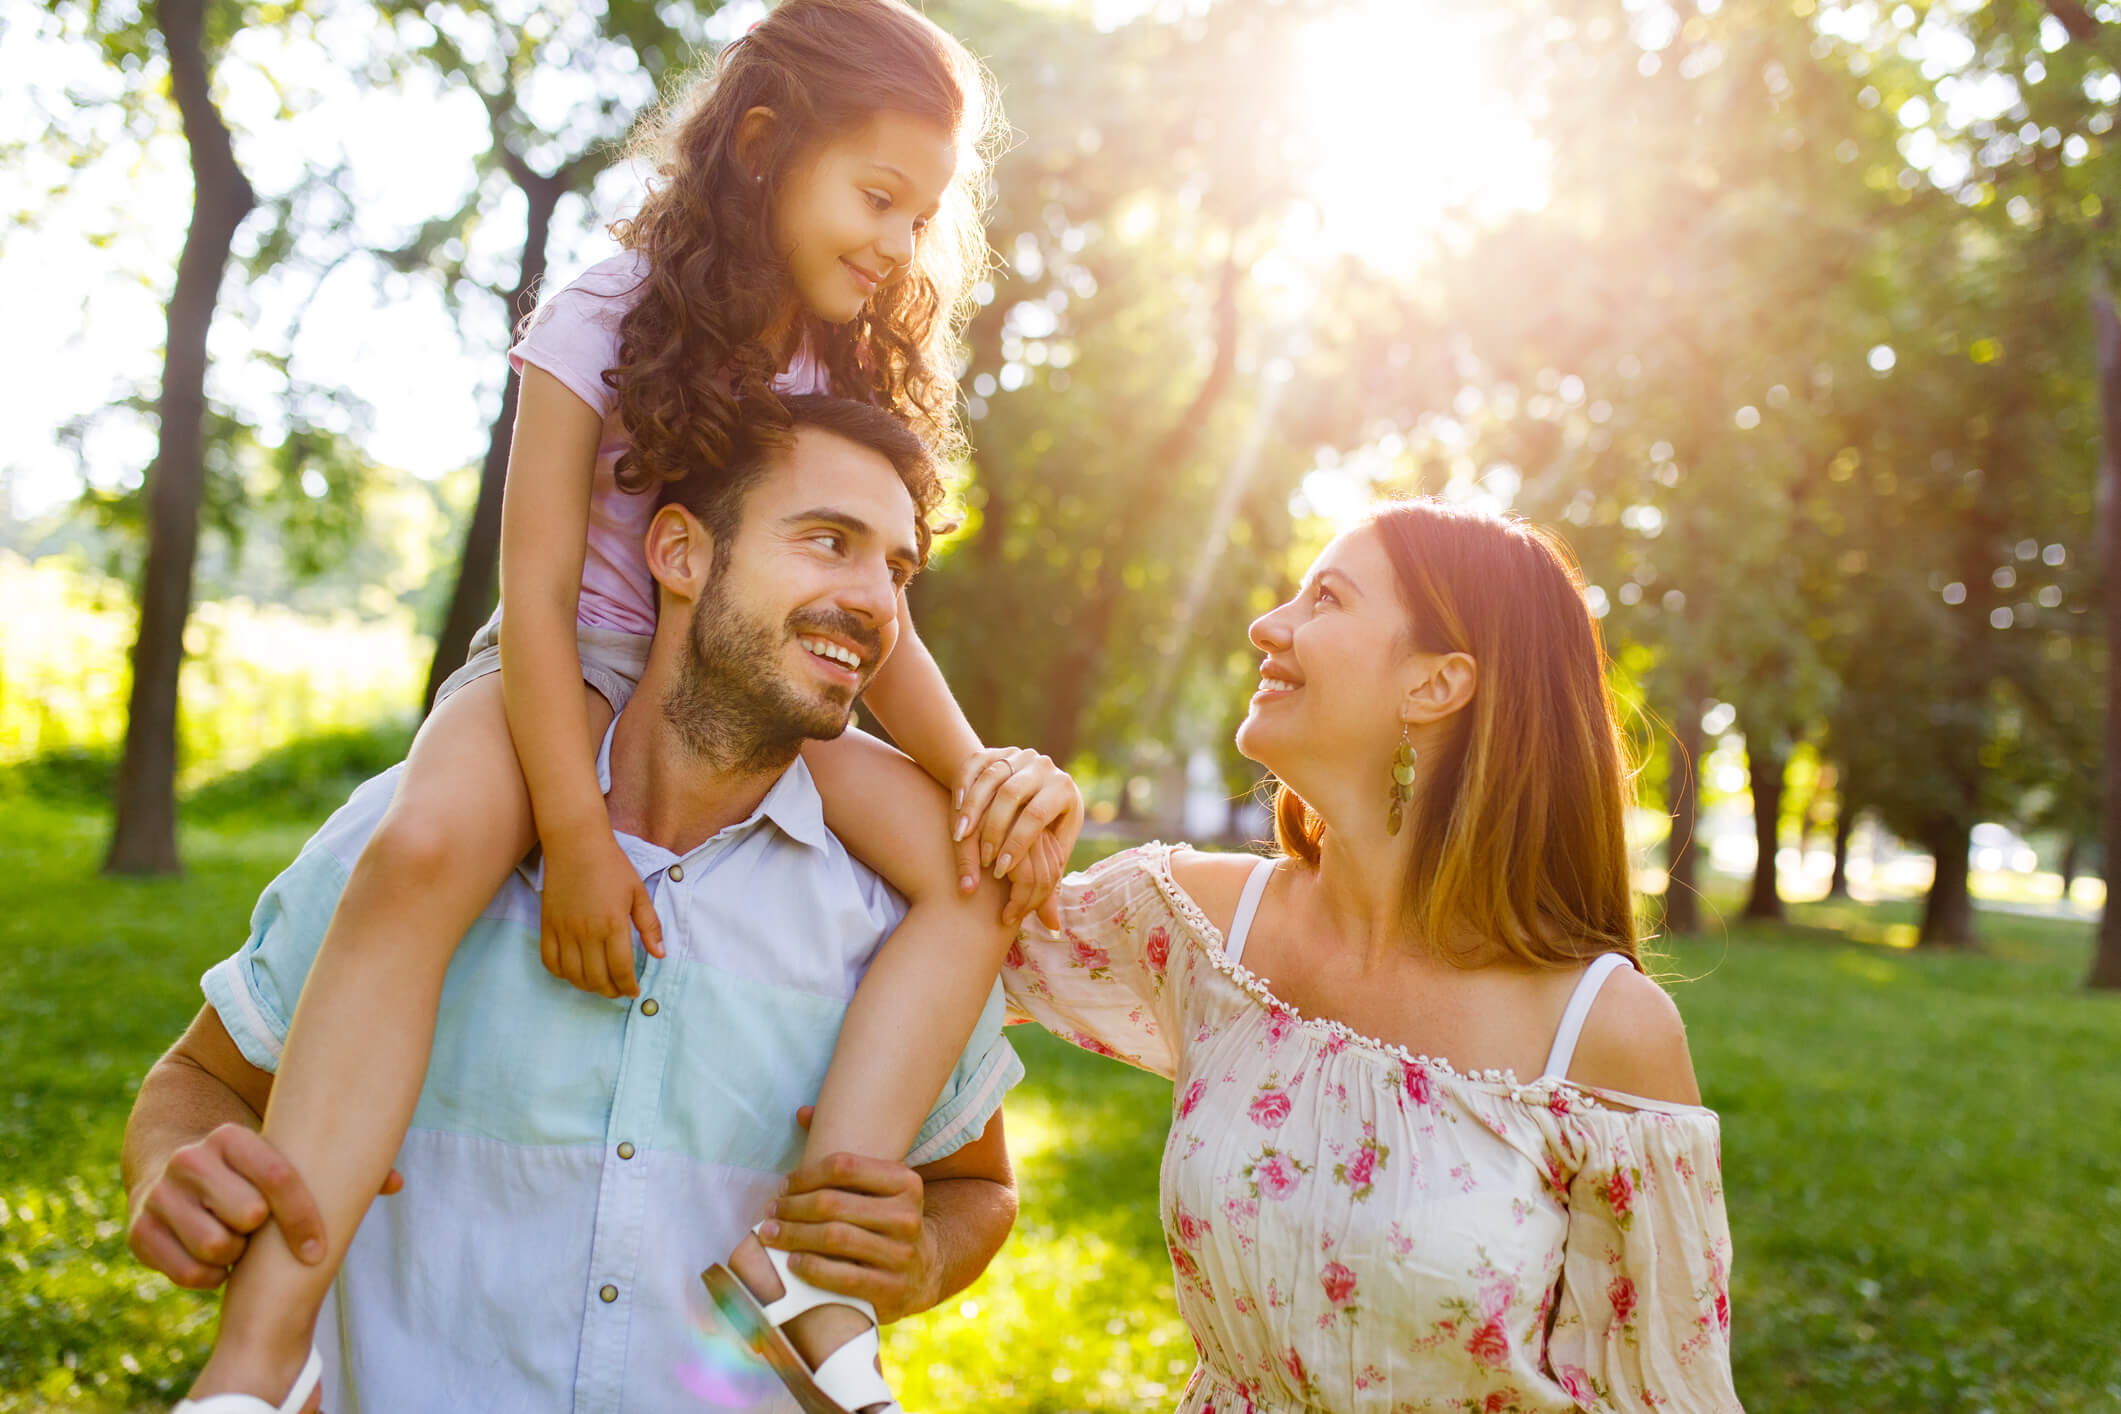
[759,1107,937,1325]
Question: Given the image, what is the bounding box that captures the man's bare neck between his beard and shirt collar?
[604,683,793,854]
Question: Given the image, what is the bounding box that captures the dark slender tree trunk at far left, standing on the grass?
[104,0,257,873]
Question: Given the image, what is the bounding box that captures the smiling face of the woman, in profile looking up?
[1237,526,1410,799]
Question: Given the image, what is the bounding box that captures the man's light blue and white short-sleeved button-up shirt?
[204,733,1022,1414]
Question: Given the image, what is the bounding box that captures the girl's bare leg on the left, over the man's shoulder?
[193,674,611,1399]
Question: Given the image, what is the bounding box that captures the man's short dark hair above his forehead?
[655,392,944,560]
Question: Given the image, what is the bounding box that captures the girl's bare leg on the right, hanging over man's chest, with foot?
[730,731,1014,1407]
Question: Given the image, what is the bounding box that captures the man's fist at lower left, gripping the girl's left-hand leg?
[125,1124,405,1291]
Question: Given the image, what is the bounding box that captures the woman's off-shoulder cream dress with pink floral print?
[1003,844,1739,1414]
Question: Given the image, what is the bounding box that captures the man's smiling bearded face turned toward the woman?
[664,428,921,767]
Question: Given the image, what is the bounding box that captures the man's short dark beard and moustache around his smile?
[664,583,882,772]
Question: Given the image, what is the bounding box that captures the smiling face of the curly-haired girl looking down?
[774,112,957,324]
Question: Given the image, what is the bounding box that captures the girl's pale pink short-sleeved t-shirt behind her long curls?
[509,250,829,634]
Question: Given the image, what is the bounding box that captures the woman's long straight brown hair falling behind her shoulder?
[1275,498,1640,965]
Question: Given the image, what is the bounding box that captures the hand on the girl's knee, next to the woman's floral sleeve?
[954,746,1082,929]
